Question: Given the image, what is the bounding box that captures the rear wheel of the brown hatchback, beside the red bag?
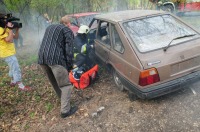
[112,69,124,91]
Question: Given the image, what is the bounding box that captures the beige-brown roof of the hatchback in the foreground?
[95,10,165,22]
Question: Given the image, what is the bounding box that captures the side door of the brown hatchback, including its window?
[94,21,111,62]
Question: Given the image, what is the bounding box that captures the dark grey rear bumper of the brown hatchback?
[119,71,200,99]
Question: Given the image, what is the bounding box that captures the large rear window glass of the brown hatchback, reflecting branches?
[123,15,197,52]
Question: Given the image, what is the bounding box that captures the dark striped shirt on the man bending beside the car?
[38,24,74,69]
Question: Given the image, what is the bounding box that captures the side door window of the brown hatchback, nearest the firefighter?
[97,21,110,46]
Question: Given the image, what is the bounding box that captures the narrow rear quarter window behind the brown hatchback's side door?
[111,24,124,53]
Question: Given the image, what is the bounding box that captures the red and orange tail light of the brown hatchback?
[139,68,160,86]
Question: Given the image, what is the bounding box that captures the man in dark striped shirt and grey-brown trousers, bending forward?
[38,16,78,118]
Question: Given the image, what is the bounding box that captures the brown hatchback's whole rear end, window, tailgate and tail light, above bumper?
[122,14,200,86]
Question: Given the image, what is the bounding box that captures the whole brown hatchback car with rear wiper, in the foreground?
[89,10,200,99]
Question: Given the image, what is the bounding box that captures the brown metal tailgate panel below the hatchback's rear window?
[137,35,200,82]
